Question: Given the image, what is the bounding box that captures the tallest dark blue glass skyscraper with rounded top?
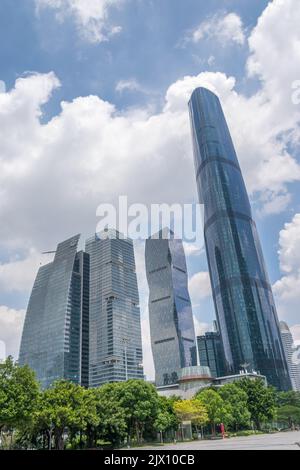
[189,88,291,390]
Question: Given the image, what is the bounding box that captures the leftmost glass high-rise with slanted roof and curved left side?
[19,235,89,388]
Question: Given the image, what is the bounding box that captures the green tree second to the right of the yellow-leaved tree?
[219,383,251,430]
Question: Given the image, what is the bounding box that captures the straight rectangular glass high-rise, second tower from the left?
[86,230,144,387]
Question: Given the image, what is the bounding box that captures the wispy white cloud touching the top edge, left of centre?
[35,0,124,43]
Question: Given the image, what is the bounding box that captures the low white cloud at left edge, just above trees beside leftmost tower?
[0,305,25,359]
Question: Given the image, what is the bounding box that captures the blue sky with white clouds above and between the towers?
[0,0,300,378]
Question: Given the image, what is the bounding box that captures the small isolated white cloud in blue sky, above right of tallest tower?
[190,13,245,46]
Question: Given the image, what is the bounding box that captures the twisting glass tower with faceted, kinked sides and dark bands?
[145,231,197,386]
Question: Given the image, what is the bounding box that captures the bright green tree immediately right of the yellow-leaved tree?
[196,389,232,434]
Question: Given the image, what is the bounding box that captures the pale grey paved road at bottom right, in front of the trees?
[135,431,300,451]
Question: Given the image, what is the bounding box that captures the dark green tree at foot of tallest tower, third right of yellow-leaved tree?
[237,378,276,429]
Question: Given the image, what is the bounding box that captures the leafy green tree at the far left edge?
[0,357,39,448]
